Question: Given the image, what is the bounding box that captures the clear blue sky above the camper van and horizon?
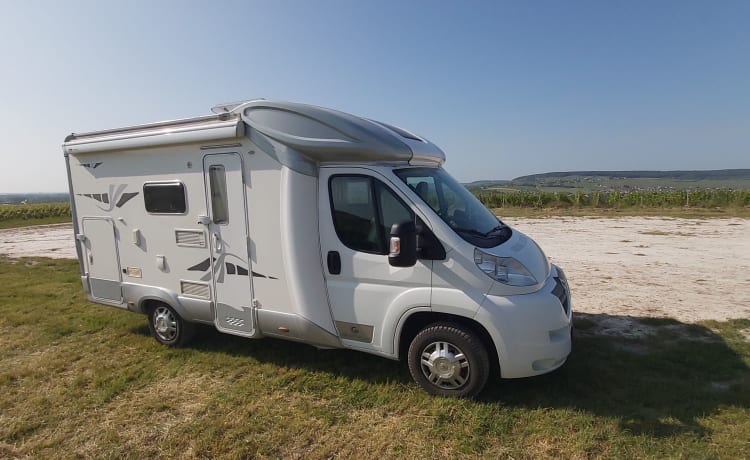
[0,0,750,193]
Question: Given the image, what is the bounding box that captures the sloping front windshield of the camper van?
[395,168,511,248]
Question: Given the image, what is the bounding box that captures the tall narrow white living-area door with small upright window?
[203,154,255,336]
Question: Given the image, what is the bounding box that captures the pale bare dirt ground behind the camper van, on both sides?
[0,217,750,329]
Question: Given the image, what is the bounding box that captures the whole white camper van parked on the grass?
[63,99,571,397]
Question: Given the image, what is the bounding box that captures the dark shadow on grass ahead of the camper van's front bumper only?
[480,314,750,437]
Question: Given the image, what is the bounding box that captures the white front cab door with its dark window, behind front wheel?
[319,168,432,351]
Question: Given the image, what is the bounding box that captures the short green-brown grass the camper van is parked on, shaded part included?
[0,259,750,458]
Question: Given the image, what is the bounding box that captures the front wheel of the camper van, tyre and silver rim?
[409,323,490,398]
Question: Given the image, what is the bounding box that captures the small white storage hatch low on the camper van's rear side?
[82,217,122,302]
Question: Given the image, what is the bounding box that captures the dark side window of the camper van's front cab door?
[329,176,414,254]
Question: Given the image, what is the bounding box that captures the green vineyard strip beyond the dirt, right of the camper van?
[474,190,750,209]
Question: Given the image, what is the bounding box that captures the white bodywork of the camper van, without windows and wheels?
[63,101,571,384]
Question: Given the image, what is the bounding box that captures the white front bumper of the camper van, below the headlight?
[475,265,572,378]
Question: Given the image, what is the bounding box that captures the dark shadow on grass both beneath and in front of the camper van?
[131,314,750,437]
